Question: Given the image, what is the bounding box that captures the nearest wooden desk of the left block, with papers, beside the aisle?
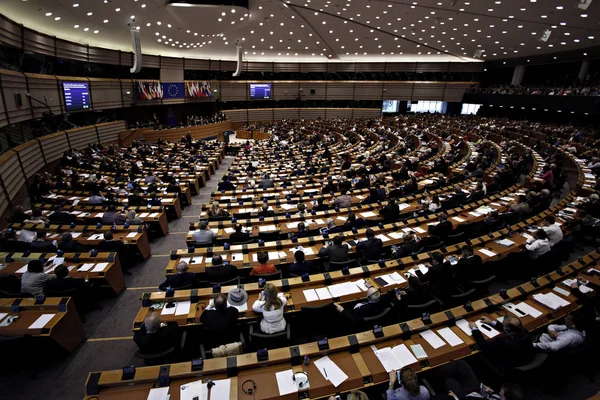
[0,297,83,354]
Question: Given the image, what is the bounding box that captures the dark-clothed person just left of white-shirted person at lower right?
[469,315,534,375]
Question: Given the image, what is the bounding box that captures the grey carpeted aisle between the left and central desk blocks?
[0,157,234,400]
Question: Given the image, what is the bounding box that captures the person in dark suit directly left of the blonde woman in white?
[200,293,239,348]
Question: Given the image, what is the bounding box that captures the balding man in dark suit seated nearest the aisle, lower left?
[133,312,179,354]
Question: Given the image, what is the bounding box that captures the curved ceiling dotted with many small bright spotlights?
[0,0,600,62]
